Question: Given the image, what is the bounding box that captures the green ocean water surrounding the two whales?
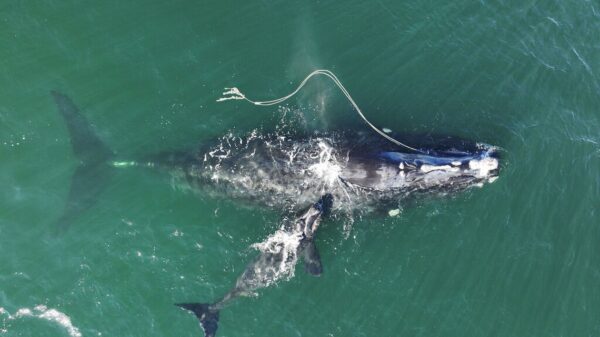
[0,0,600,337]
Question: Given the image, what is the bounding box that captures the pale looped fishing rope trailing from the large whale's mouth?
[217,69,425,153]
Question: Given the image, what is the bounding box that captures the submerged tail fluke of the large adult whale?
[51,91,114,231]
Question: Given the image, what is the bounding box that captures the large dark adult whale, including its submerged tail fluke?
[52,92,499,228]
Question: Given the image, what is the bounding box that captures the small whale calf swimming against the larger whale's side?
[176,194,333,337]
